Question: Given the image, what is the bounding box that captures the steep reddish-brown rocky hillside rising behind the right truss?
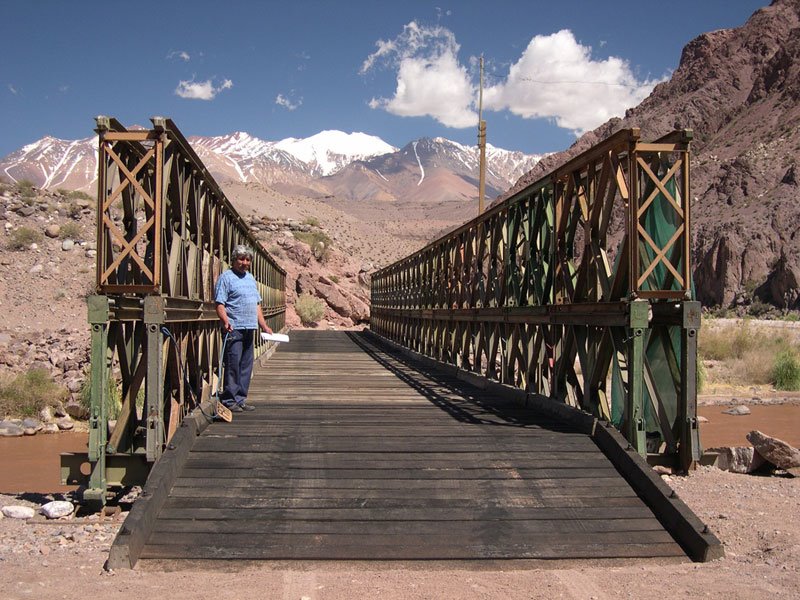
[507,0,800,309]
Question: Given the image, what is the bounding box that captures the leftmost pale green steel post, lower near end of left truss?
[83,296,109,510]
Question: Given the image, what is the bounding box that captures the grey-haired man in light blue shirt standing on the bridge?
[214,245,272,412]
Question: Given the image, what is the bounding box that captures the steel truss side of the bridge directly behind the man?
[62,117,286,504]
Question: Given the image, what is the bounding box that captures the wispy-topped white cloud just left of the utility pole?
[359,21,477,128]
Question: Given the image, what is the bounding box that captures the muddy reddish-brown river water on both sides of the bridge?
[0,404,800,494]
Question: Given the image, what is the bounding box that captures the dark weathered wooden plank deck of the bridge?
[136,331,685,560]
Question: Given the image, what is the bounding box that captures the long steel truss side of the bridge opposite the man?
[371,129,700,468]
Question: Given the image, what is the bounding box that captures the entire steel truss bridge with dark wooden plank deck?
[62,117,722,568]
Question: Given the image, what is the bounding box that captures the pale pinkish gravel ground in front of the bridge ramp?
[0,468,800,600]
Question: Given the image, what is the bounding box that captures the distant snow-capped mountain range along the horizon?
[0,131,541,202]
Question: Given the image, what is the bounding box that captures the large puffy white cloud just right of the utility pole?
[483,29,664,135]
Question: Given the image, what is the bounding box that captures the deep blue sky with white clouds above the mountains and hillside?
[0,0,767,156]
